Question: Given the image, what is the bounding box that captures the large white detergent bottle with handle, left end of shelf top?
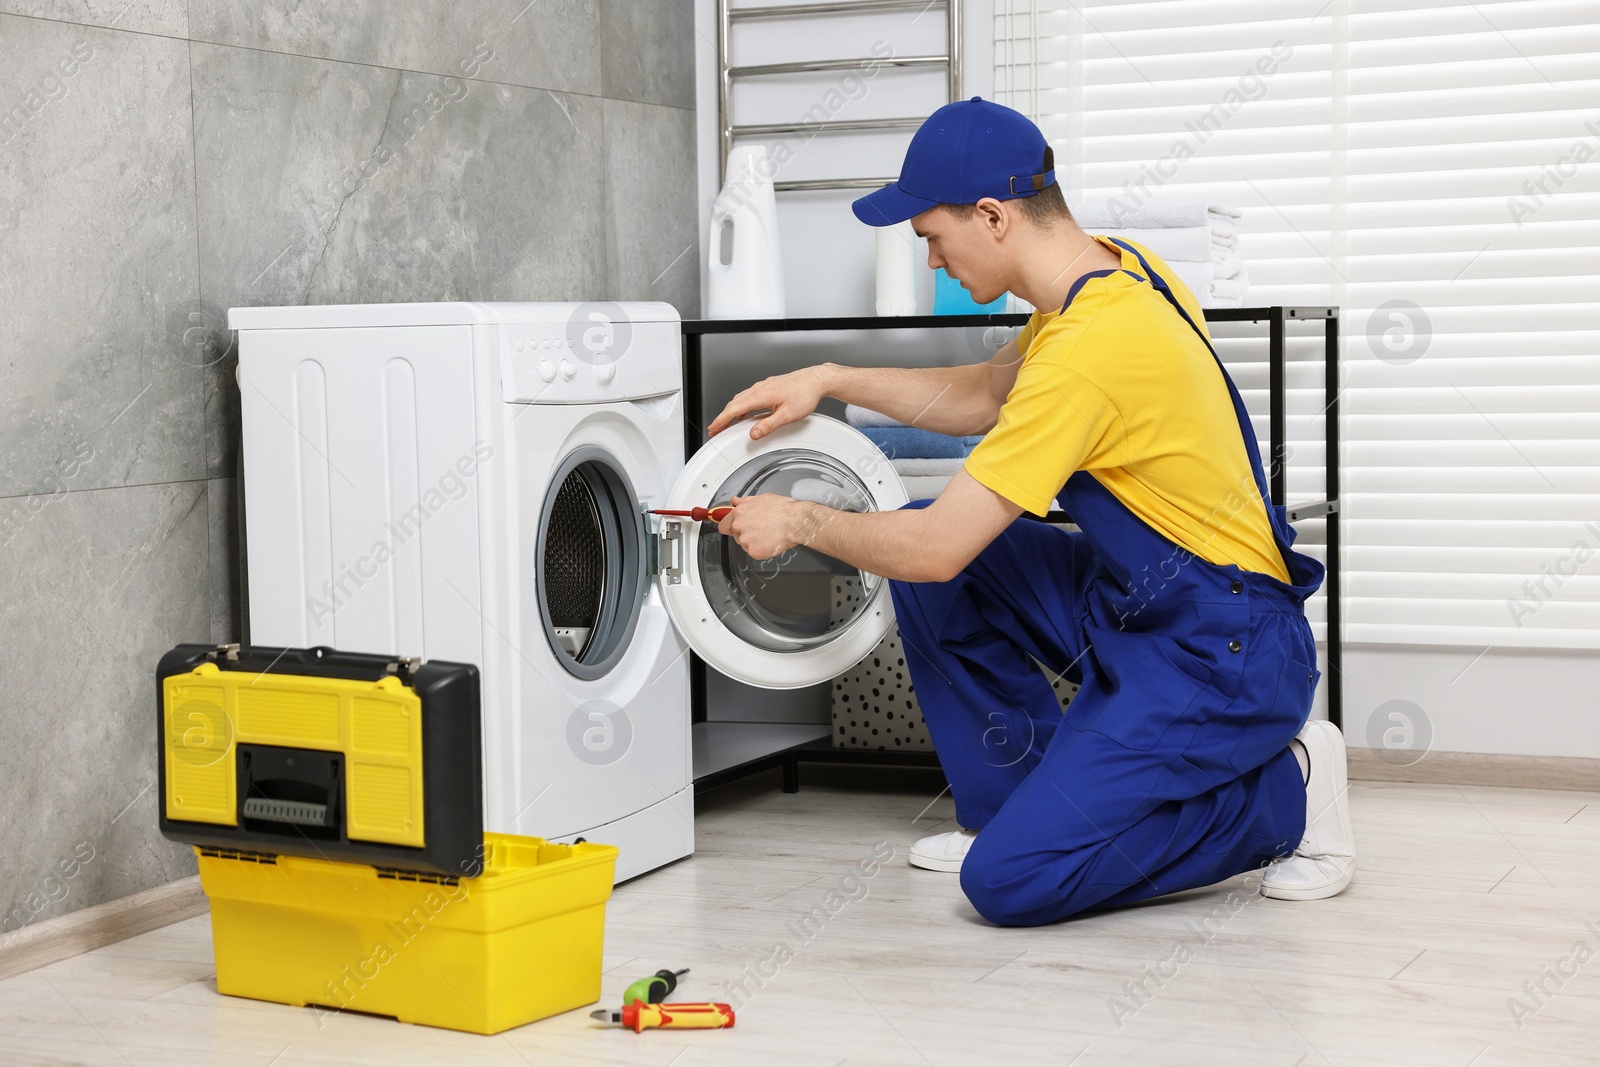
[706,144,784,318]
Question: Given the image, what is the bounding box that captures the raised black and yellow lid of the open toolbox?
[155,645,483,878]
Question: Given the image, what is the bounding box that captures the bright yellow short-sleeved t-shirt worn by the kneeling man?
[966,237,1290,582]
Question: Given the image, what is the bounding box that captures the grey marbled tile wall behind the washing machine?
[0,0,699,945]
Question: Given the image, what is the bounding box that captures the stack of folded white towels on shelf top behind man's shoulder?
[1074,202,1250,307]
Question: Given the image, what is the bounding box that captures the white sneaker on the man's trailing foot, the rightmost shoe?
[1261,718,1355,901]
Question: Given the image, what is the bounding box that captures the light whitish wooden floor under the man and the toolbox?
[0,768,1600,1067]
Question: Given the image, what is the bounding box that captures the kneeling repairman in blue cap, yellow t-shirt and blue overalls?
[709,98,1355,926]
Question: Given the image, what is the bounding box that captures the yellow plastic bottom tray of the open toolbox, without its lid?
[200,833,616,1033]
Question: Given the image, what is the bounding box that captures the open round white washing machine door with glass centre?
[653,414,906,689]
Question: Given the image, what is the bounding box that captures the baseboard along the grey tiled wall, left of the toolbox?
[0,875,206,979]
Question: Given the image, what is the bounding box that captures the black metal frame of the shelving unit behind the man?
[683,307,1344,792]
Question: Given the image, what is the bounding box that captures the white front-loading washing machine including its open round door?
[229,302,906,880]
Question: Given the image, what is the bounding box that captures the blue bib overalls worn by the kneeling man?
[890,240,1323,926]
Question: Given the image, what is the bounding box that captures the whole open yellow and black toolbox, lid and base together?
[157,645,618,1033]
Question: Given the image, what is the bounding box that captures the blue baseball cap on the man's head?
[850,96,1056,226]
